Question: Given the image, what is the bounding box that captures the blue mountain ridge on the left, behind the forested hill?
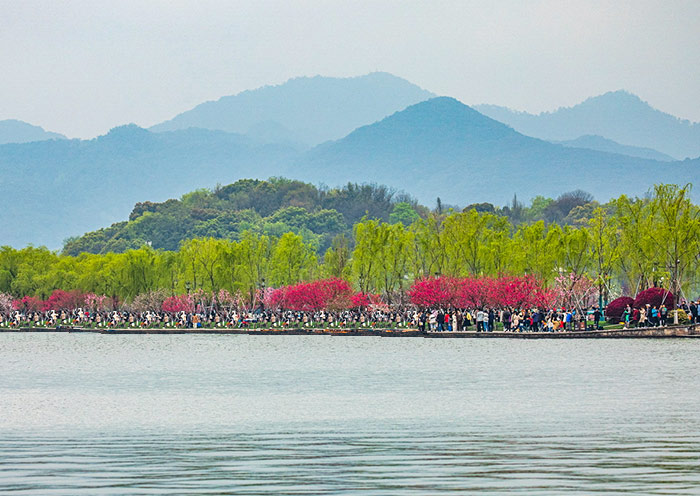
[0,125,297,248]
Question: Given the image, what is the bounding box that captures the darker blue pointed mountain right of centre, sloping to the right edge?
[294,97,700,205]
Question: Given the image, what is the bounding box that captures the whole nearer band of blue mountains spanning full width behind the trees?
[0,97,700,248]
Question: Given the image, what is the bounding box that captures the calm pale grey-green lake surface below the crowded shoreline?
[0,333,700,496]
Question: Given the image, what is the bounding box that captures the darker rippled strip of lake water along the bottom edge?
[0,431,700,494]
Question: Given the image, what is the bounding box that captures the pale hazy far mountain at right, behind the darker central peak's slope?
[474,90,700,158]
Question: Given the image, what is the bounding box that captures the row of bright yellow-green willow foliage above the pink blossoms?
[0,185,700,301]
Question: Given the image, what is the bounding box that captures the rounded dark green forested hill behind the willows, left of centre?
[63,178,427,255]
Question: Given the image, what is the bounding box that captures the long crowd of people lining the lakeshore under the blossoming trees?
[0,302,700,332]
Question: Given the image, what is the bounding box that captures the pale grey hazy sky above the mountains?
[0,0,700,138]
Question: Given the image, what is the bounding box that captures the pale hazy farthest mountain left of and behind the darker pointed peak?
[151,72,434,146]
